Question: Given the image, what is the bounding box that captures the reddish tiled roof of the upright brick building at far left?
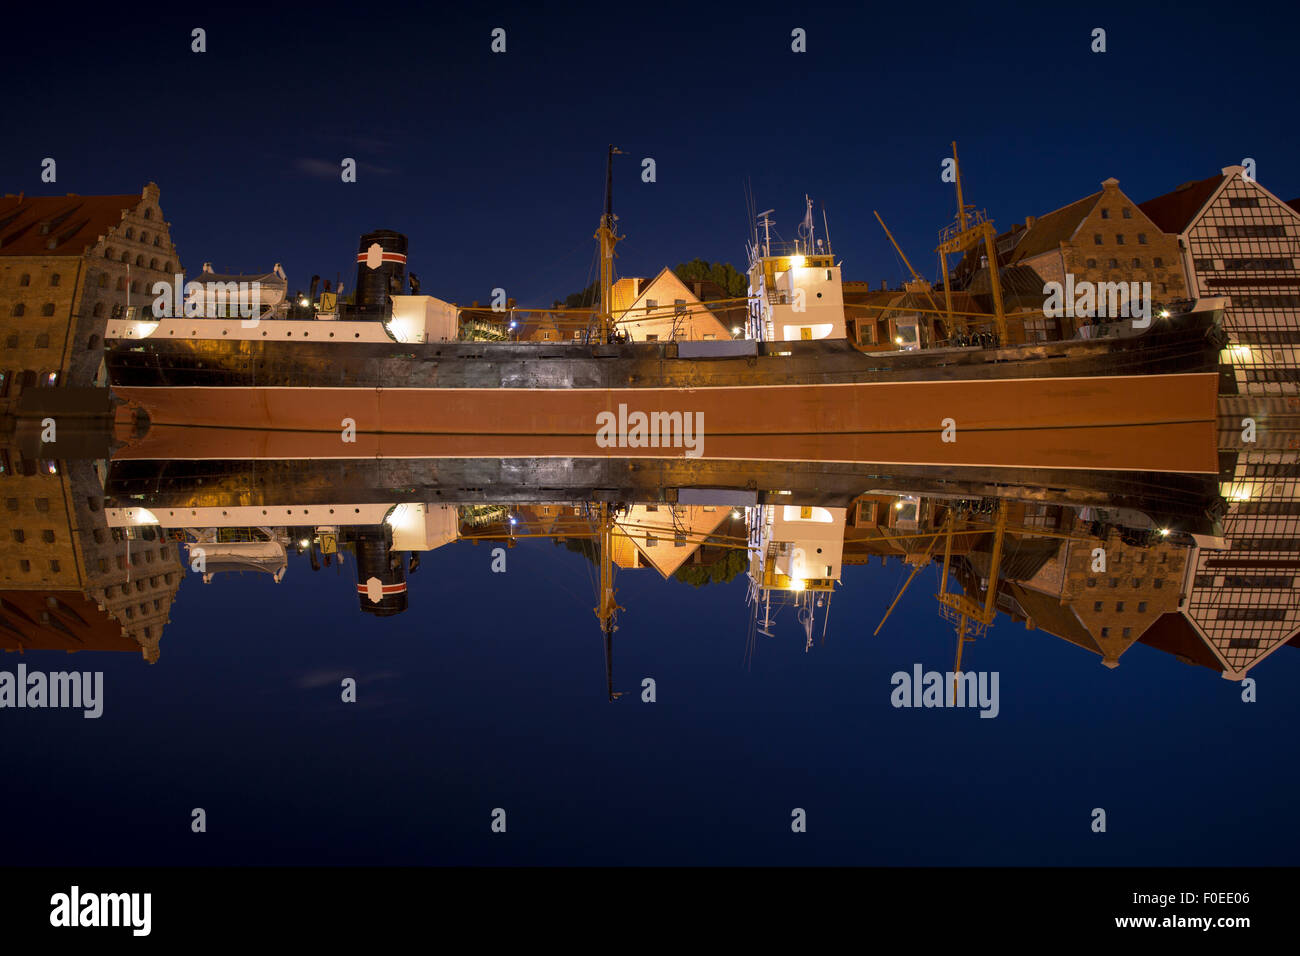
[0,193,140,256]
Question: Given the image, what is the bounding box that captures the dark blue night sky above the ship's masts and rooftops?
[0,3,1300,306]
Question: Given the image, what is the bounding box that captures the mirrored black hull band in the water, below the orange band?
[105,458,1225,535]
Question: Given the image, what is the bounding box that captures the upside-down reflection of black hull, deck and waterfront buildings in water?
[0,441,1300,700]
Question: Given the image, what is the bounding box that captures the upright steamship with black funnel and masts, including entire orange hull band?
[105,147,1226,473]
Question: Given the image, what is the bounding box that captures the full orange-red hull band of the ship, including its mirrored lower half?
[114,373,1218,473]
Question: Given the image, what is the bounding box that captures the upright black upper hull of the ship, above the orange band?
[107,312,1226,389]
